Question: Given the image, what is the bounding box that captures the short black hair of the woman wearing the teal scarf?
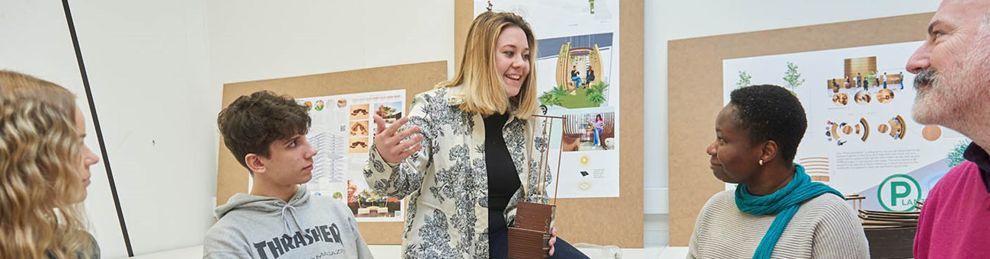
[729,85,808,163]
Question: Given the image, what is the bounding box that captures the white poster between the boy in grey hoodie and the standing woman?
[297,90,406,222]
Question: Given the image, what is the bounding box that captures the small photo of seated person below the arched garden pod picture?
[561,112,616,152]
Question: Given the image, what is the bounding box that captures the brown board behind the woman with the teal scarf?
[667,13,932,246]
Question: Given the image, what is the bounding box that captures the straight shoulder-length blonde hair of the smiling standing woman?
[437,11,539,119]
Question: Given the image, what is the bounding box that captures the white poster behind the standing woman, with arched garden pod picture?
[474,0,621,198]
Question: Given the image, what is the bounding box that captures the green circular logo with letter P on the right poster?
[877,174,921,211]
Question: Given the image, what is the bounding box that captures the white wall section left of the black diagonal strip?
[0,0,126,258]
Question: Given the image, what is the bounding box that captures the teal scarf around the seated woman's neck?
[736,164,842,259]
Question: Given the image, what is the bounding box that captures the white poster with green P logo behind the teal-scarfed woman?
[722,42,969,211]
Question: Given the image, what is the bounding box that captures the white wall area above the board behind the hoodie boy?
[208,0,454,84]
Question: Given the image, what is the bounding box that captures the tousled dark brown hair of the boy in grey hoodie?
[217,90,311,173]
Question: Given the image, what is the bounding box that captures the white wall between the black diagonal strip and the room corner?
[71,0,216,257]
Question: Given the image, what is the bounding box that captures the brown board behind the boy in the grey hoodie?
[217,61,447,244]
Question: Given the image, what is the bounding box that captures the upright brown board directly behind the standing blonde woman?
[454,0,643,248]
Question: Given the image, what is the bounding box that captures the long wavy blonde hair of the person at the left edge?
[0,70,94,258]
